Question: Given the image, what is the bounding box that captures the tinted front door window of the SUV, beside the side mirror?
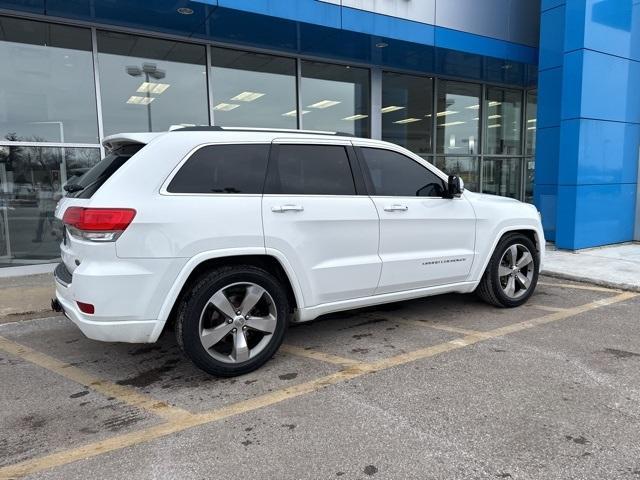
[360,148,445,197]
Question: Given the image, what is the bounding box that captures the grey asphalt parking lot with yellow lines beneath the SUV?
[0,277,640,480]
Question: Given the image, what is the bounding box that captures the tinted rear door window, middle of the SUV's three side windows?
[265,145,356,195]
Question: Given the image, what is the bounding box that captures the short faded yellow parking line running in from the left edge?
[0,336,190,420]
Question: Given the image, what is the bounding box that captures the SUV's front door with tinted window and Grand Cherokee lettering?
[359,147,476,293]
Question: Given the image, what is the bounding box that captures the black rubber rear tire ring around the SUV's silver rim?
[177,267,289,376]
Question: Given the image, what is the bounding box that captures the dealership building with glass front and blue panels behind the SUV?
[0,0,640,267]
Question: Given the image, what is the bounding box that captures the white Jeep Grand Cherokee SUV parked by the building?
[52,127,545,376]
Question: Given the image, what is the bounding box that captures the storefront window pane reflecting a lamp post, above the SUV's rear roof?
[98,31,209,135]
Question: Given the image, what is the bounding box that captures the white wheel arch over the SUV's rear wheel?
[154,250,304,338]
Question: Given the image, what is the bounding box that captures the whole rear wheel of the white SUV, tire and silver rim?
[176,265,289,377]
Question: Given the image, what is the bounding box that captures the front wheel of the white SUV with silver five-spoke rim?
[476,233,540,308]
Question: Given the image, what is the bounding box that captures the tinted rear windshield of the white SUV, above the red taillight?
[65,143,144,198]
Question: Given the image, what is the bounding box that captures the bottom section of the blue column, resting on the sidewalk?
[556,183,636,250]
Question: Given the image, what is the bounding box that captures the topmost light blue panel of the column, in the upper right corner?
[567,0,640,61]
